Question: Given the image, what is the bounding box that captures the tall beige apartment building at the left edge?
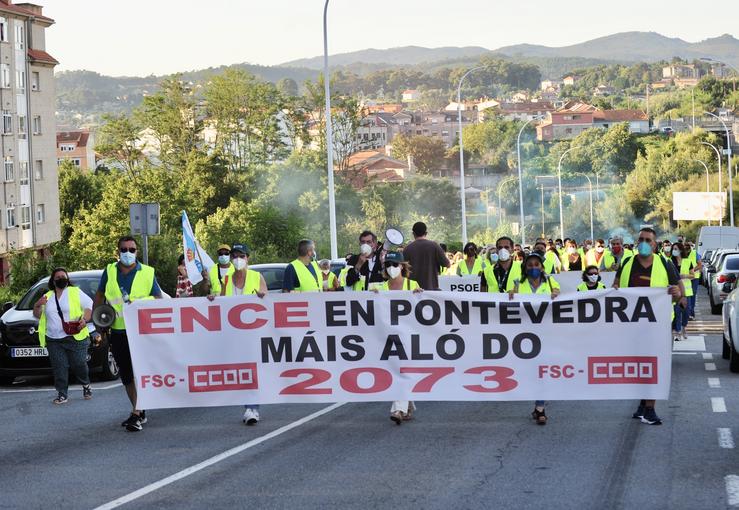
[0,0,60,283]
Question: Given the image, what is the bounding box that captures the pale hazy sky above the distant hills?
[40,0,739,76]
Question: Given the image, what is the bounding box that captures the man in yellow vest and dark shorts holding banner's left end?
[94,236,162,432]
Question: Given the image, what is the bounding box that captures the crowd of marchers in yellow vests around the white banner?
[33,222,701,432]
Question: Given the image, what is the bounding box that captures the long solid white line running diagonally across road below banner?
[95,402,346,510]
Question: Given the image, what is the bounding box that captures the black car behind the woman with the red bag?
[0,271,118,384]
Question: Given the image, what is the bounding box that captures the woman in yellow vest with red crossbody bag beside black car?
[33,267,100,404]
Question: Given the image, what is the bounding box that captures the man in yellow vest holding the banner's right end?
[613,227,686,425]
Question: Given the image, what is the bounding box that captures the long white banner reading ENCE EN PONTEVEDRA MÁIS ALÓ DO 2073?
[124,288,672,409]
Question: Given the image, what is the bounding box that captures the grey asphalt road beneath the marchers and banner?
[0,289,739,509]
